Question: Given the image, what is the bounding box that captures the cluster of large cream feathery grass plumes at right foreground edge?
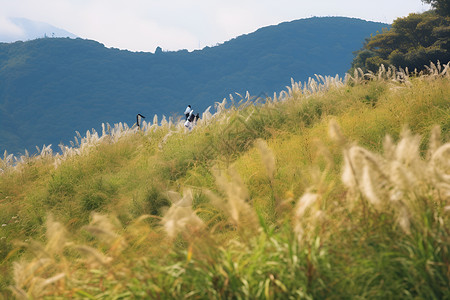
[330,124,450,233]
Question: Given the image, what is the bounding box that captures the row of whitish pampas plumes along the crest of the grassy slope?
[0,62,450,175]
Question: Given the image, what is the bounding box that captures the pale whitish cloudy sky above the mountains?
[0,0,430,52]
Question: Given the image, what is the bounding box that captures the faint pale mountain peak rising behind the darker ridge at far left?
[0,18,77,43]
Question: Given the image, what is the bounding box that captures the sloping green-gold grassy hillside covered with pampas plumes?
[0,65,450,299]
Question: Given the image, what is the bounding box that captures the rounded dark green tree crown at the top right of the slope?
[352,11,450,72]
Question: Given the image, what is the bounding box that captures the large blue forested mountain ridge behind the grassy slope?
[0,17,389,153]
